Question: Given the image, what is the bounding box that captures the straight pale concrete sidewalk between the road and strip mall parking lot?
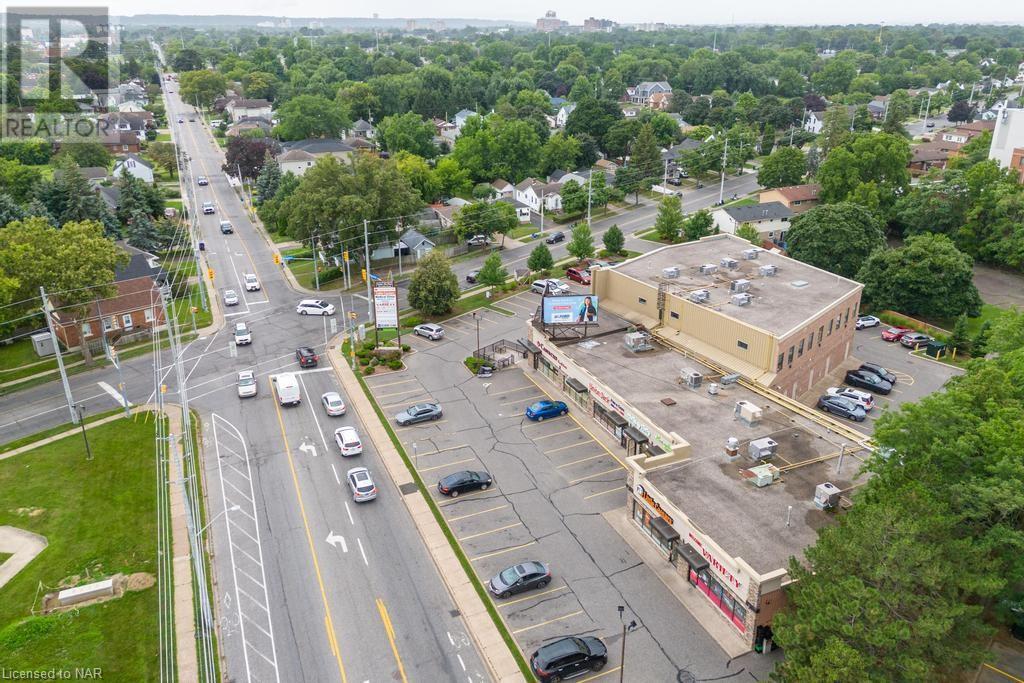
[323,336,523,683]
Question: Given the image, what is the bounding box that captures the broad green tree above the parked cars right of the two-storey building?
[856,235,981,318]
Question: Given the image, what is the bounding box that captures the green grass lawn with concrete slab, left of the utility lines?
[0,417,159,681]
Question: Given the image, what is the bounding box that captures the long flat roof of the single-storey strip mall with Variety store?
[559,311,863,573]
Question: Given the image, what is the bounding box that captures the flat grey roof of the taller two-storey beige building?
[615,233,861,337]
